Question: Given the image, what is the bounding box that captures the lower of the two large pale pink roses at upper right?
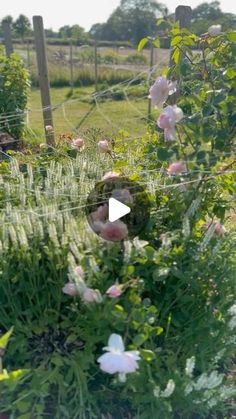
[157,105,184,141]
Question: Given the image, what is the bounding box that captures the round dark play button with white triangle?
[86,176,150,241]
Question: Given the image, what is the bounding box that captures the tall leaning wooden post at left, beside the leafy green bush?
[33,16,54,145]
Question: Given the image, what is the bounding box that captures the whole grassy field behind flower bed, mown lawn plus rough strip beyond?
[16,45,169,141]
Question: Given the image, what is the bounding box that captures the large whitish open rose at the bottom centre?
[98,333,140,381]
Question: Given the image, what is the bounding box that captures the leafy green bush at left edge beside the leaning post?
[0,54,30,139]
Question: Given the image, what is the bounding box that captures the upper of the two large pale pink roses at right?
[148,76,176,107]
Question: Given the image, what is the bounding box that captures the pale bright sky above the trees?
[0,0,236,30]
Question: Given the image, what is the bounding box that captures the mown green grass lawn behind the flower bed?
[27,87,147,141]
